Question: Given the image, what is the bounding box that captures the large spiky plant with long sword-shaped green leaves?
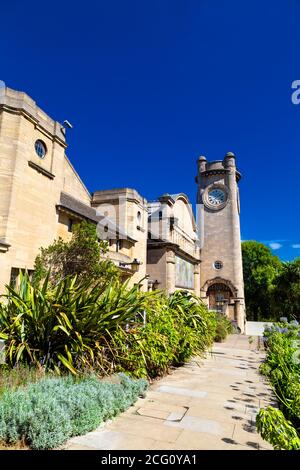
[0,274,154,374]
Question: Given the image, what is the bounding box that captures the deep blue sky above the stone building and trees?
[0,0,300,259]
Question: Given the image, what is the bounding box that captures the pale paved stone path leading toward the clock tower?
[65,335,274,450]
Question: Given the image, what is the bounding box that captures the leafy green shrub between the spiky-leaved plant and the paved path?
[111,291,215,378]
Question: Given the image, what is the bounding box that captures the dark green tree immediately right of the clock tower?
[242,241,282,321]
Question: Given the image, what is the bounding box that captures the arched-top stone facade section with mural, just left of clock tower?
[147,193,200,294]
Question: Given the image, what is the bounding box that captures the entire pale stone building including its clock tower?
[0,87,245,331]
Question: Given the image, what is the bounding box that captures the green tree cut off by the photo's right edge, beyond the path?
[273,258,300,321]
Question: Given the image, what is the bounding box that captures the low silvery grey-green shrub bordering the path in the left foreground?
[0,376,147,449]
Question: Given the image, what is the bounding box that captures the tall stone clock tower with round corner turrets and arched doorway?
[196,152,245,333]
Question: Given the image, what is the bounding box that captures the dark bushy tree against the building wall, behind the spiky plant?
[34,221,119,283]
